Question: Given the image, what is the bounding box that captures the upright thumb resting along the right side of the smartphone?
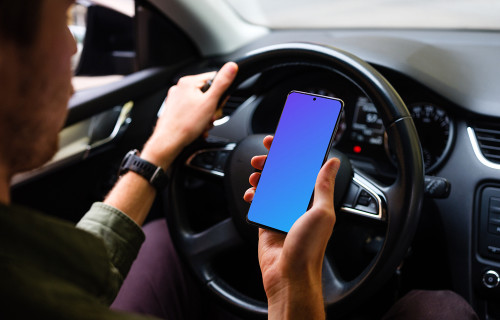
[313,158,340,209]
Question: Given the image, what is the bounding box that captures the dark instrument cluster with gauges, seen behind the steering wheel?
[244,68,456,181]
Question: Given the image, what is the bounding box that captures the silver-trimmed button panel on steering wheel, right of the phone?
[340,170,387,221]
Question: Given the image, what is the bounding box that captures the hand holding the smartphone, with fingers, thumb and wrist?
[244,136,340,319]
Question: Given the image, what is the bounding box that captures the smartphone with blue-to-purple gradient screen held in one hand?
[247,91,344,233]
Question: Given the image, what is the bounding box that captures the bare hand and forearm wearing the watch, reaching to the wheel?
[104,63,238,225]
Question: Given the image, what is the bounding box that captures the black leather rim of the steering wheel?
[167,43,424,315]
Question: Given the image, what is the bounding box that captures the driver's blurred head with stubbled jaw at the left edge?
[0,0,76,178]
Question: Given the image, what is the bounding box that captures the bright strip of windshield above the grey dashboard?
[226,0,500,30]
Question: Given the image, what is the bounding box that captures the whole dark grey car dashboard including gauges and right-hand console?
[213,30,500,318]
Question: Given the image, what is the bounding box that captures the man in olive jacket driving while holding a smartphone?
[0,0,339,319]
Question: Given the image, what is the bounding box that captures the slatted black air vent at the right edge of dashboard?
[474,123,500,163]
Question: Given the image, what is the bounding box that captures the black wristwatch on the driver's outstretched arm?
[118,150,168,190]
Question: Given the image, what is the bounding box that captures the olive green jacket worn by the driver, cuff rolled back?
[0,203,158,319]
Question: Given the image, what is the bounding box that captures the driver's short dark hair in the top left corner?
[0,0,45,46]
